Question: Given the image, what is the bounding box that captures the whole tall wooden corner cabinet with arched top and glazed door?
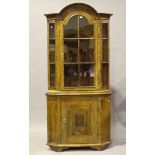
[45,3,111,151]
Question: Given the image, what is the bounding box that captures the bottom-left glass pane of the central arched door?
[64,64,79,87]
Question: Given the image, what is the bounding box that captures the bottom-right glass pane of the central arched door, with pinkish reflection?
[80,64,94,86]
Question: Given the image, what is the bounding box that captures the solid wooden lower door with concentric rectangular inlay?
[61,96,98,144]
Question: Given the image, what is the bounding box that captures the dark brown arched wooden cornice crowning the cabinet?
[45,3,112,20]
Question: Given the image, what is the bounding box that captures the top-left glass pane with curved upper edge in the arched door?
[64,16,78,38]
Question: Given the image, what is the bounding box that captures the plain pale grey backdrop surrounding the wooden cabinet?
[29,0,126,155]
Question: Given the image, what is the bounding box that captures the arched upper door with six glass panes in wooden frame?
[60,13,97,90]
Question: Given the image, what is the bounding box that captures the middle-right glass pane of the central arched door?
[80,39,94,62]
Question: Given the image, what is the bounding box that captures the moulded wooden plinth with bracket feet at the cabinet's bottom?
[48,142,110,152]
